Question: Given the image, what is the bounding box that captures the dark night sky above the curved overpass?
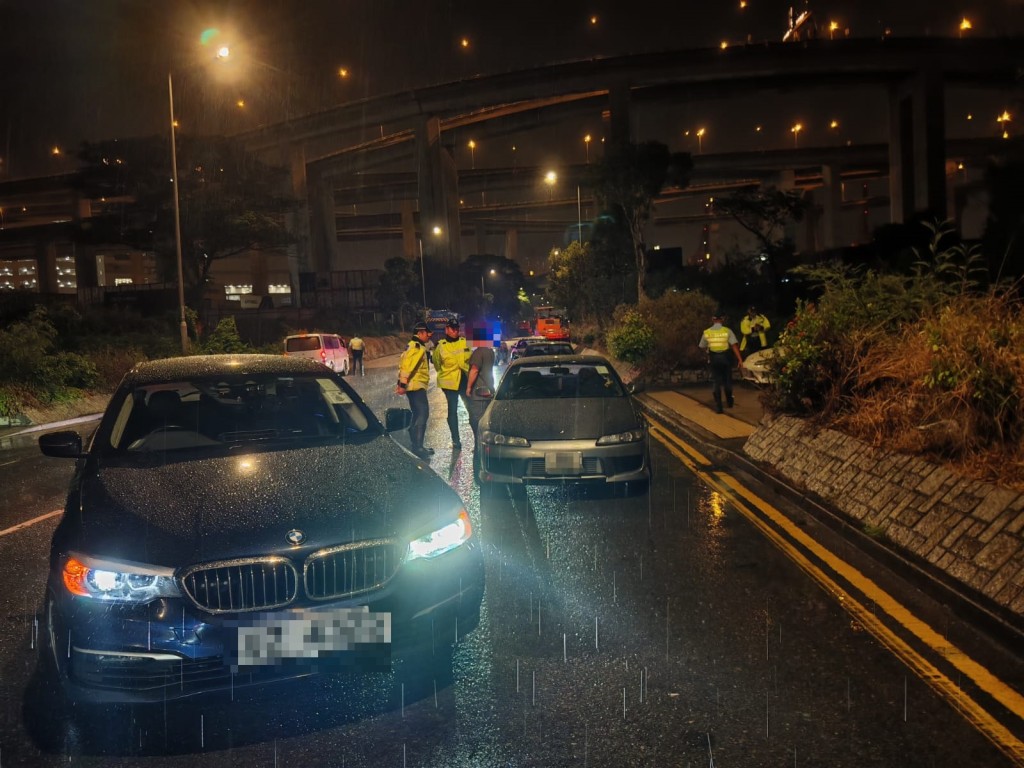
[0,0,1024,178]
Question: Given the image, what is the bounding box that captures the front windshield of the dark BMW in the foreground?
[97,375,378,454]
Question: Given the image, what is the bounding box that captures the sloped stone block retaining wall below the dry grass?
[743,416,1024,616]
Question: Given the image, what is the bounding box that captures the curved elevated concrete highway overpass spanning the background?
[234,38,1024,280]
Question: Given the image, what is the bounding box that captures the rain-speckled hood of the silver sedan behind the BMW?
[481,397,640,440]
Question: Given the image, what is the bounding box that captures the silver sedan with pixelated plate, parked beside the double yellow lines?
[477,355,650,493]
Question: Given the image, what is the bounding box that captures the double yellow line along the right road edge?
[650,422,1024,766]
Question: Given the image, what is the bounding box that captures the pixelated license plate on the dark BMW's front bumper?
[225,606,391,669]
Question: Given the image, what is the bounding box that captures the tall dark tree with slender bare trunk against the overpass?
[594,141,693,301]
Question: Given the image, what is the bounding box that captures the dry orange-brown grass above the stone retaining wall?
[834,296,1024,490]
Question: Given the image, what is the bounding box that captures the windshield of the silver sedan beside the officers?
[496,362,626,400]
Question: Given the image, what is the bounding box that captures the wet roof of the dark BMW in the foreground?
[125,354,332,386]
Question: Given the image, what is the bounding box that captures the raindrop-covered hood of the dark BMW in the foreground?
[68,436,461,567]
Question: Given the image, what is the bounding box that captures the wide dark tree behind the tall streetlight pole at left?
[79,135,298,302]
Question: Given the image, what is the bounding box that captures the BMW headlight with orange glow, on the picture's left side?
[61,552,181,603]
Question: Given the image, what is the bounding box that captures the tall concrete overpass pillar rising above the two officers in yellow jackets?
[416,117,462,267]
